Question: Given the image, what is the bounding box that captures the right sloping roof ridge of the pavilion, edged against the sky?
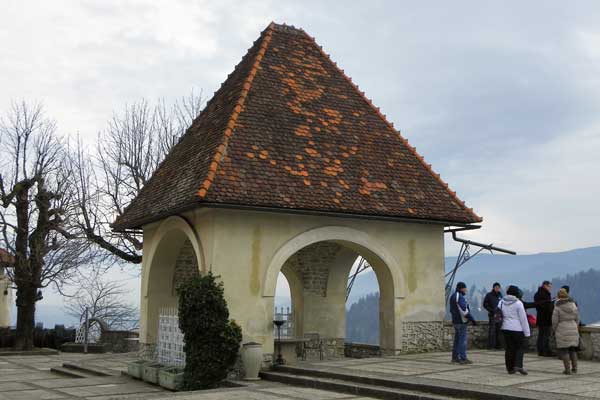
[296,28,483,222]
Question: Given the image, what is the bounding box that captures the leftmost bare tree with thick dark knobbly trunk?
[0,102,89,350]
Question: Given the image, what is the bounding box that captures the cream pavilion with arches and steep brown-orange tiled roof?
[113,23,482,360]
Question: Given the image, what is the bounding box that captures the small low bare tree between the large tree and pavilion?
[65,268,139,330]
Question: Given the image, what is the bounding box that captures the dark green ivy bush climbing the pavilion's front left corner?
[177,273,242,390]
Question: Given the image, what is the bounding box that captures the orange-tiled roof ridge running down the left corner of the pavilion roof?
[197,22,275,198]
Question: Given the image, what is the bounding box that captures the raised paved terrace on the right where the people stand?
[299,350,600,399]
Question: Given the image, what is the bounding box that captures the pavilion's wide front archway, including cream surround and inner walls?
[263,227,403,355]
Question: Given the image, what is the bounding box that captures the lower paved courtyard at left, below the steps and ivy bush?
[0,353,372,400]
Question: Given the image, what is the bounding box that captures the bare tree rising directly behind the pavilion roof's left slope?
[70,91,204,263]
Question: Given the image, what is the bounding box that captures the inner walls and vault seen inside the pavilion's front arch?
[267,231,398,356]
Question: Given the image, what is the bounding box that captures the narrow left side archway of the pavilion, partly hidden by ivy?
[140,221,201,344]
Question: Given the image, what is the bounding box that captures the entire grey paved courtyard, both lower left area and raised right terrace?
[0,351,600,400]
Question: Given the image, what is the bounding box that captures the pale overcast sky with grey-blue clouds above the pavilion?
[0,0,600,314]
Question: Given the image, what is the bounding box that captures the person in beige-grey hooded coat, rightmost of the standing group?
[552,288,579,375]
